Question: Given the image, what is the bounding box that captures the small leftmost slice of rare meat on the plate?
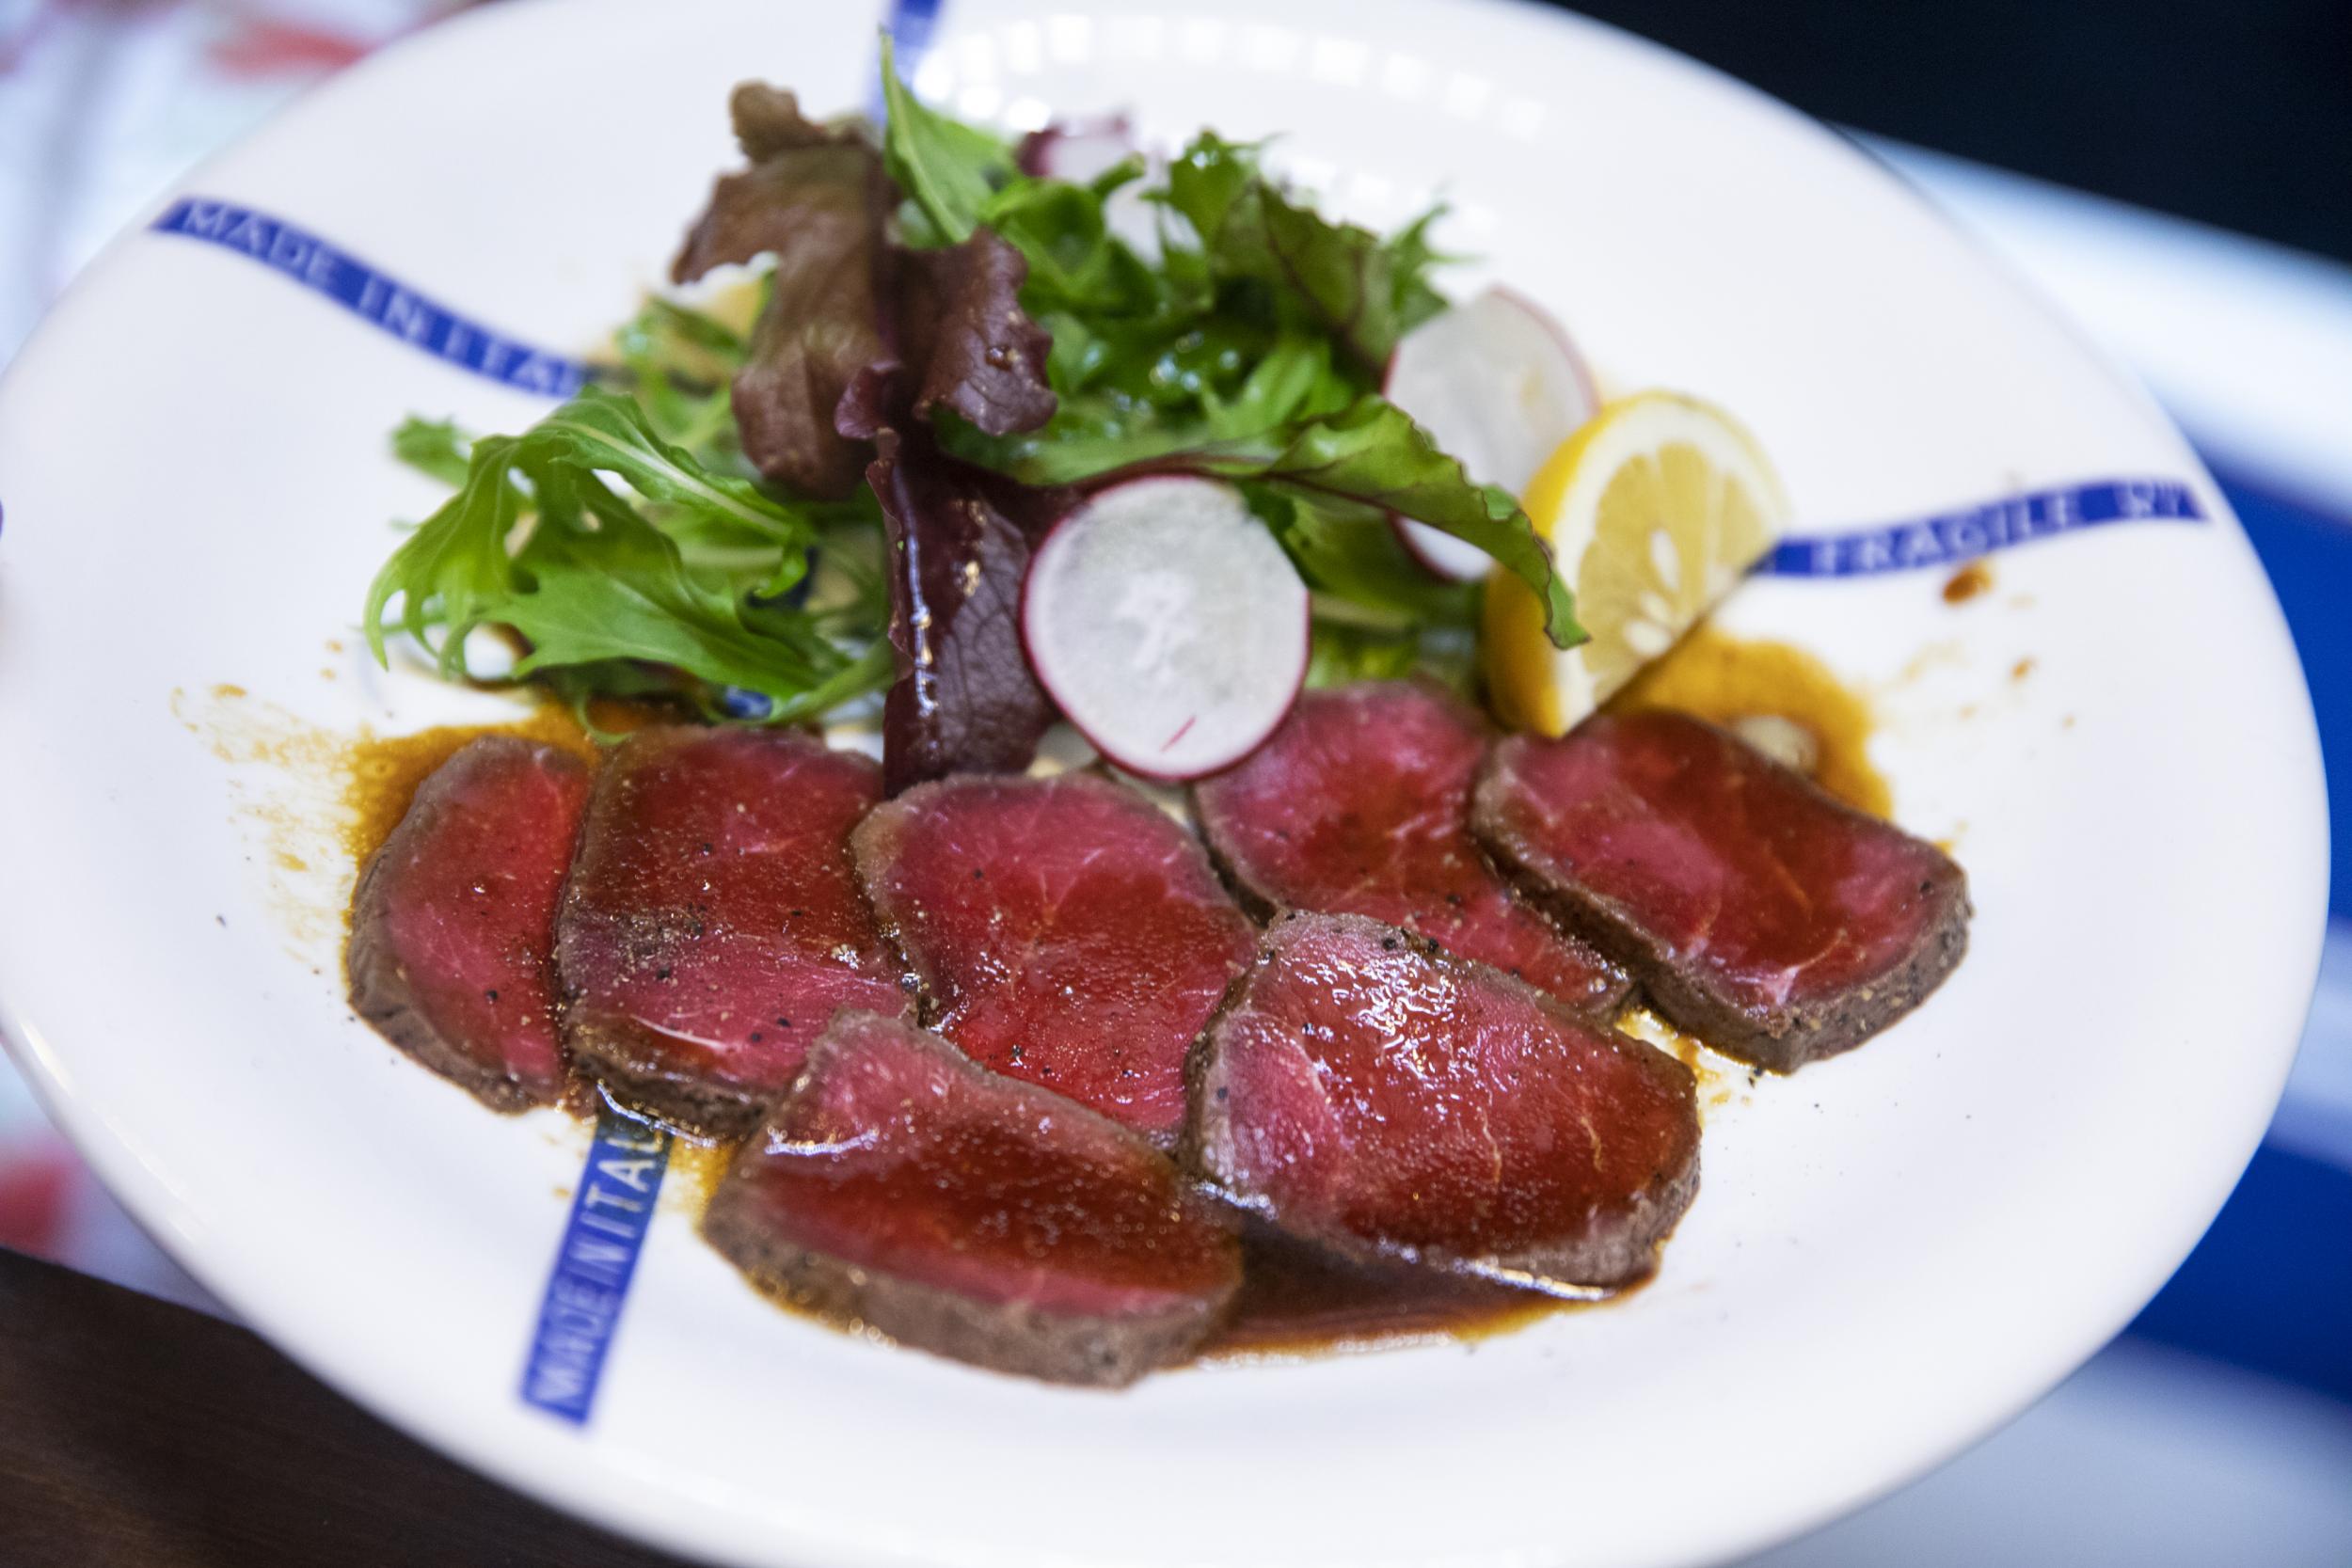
[343,736,588,1110]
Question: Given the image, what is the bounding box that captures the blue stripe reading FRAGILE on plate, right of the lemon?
[1757,480,2204,576]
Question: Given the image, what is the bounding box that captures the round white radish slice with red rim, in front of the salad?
[1021,475,1308,781]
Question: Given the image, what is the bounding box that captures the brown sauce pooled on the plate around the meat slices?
[326,626,1891,1361]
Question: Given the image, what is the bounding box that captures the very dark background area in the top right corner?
[1552,0,2352,261]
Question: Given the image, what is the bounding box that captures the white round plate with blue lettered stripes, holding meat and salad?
[0,0,2327,1568]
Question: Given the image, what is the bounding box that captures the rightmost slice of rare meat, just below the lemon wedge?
[1472,712,1969,1072]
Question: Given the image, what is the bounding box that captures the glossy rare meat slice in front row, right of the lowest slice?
[1185,914,1698,1291]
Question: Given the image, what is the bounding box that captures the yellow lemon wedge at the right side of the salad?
[1485,392,1788,736]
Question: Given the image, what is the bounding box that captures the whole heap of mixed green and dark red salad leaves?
[365,44,1583,776]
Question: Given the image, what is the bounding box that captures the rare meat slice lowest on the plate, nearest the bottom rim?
[704,1013,1242,1385]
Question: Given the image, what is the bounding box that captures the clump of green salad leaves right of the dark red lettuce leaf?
[861,72,1583,646]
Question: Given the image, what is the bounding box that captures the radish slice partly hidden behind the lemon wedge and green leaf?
[1381,289,1602,583]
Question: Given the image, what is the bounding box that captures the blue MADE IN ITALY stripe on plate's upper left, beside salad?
[153,195,593,397]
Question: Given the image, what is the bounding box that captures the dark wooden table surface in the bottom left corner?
[0,1251,696,1568]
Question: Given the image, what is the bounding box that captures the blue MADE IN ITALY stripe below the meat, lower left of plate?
[522,1105,671,1425]
